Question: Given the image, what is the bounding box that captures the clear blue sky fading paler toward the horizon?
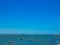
[0,0,60,34]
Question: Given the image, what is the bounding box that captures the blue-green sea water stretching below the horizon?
[0,35,60,45]
